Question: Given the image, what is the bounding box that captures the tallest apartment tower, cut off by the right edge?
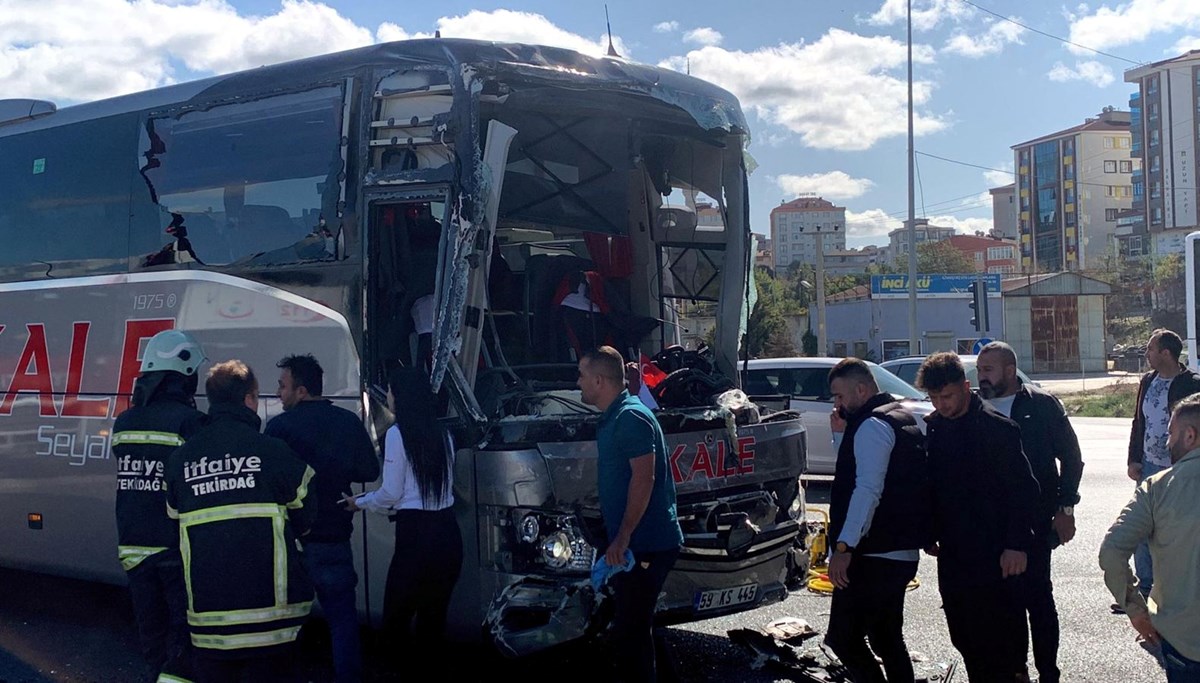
[1124,49,1200,253]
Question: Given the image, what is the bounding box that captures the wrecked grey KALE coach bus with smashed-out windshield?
[0,40,804,654]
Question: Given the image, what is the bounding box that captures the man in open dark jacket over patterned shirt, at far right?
[1114,329,1200,600]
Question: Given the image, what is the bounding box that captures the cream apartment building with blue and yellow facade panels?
[1013,107,1138,272]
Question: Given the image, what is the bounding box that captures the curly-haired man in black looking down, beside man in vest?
[917,353,1039,683]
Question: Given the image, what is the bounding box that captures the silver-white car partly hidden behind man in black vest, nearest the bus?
[742,358,934,474]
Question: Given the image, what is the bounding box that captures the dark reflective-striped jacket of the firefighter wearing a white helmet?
[112,372,204,571]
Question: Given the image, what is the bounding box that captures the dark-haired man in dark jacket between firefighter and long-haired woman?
[264,355,379,683]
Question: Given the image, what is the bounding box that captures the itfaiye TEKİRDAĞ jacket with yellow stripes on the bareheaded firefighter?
[166,405,317,659]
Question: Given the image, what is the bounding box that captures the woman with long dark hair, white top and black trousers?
[344,367,462,647]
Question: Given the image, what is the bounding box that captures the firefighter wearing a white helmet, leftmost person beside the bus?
[113,330,205,681]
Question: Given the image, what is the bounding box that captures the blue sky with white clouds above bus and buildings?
[0,0,1200,246]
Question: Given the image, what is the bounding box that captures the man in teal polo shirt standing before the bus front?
[578,346,683,682]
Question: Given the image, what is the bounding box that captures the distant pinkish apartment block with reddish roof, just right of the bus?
[770,197,846,269]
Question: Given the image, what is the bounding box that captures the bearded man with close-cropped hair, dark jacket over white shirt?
[976,342,1084,683]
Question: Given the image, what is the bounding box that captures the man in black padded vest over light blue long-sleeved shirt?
[826,358,931,683]
